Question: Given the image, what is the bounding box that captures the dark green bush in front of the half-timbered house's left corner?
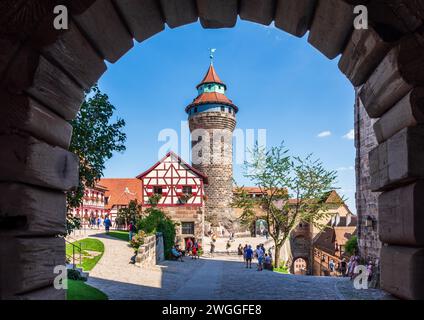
[137,207,176,259]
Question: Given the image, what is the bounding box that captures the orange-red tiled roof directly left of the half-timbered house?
[99,178,142,209]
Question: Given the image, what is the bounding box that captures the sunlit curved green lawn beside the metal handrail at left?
[66,238,105,271]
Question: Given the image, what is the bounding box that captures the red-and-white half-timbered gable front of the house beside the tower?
[137,151,207,207]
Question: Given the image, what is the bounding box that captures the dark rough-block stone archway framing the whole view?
[0,0,424,299]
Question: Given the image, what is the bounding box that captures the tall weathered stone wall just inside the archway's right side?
[355,88,381,260]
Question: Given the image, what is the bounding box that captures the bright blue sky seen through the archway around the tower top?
[99,20,356,211]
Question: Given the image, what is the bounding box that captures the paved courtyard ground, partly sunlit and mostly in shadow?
[83,234,391,300]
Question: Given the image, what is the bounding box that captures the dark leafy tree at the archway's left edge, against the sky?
[67,84,126,233]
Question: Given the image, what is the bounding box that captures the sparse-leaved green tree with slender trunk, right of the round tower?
[232,143,342,268]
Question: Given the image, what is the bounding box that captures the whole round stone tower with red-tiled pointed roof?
[186,62,238,230]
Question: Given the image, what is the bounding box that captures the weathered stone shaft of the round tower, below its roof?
[189,112,236,230]
